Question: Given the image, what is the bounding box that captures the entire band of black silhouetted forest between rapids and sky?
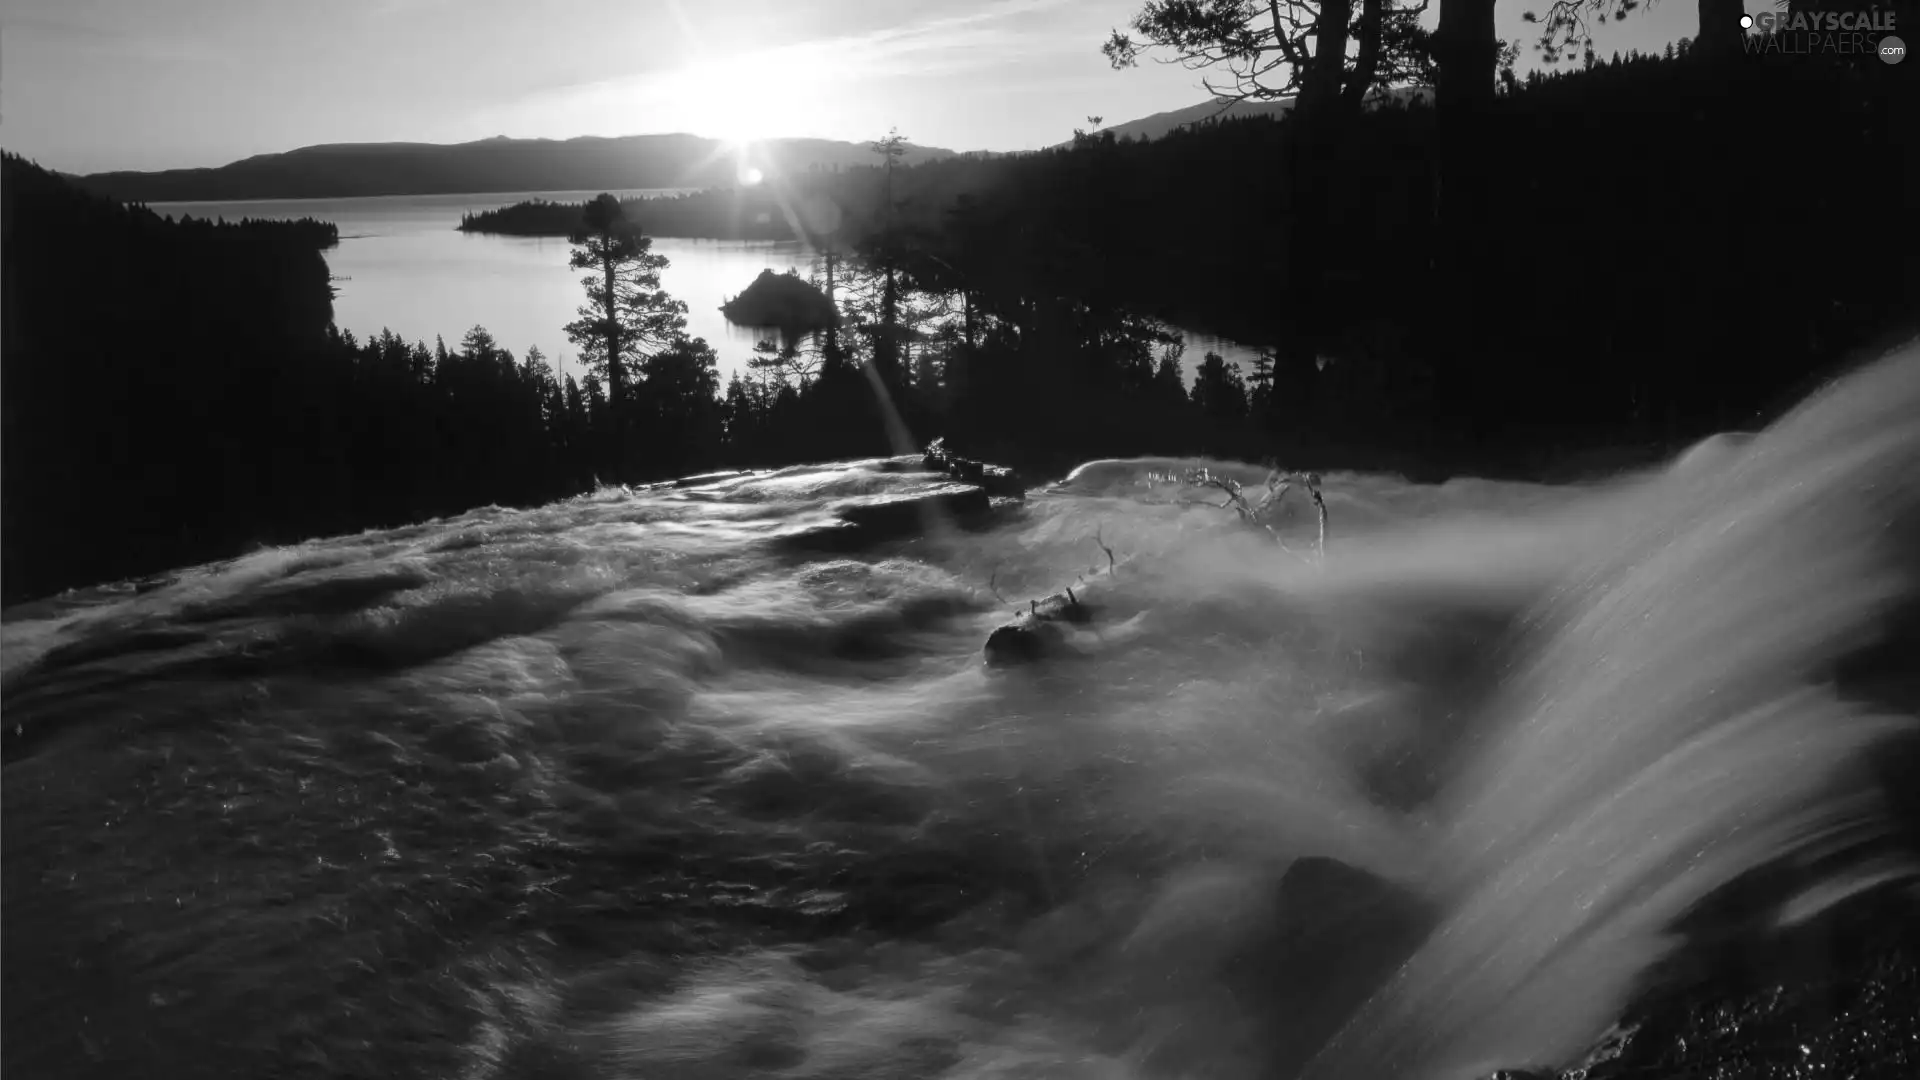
[0,4,1920,603]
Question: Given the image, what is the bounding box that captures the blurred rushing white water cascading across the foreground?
[11,340,1920,1080]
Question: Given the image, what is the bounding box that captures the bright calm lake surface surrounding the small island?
[150,190,1254,382]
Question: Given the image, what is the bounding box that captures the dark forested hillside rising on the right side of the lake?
[456,42,1920,465]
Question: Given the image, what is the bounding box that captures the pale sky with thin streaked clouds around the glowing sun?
[0,0,1728,173]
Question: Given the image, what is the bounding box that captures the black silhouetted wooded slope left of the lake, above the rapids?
[0,156,718,603]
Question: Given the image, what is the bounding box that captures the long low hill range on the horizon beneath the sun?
[75,135,952,202]
